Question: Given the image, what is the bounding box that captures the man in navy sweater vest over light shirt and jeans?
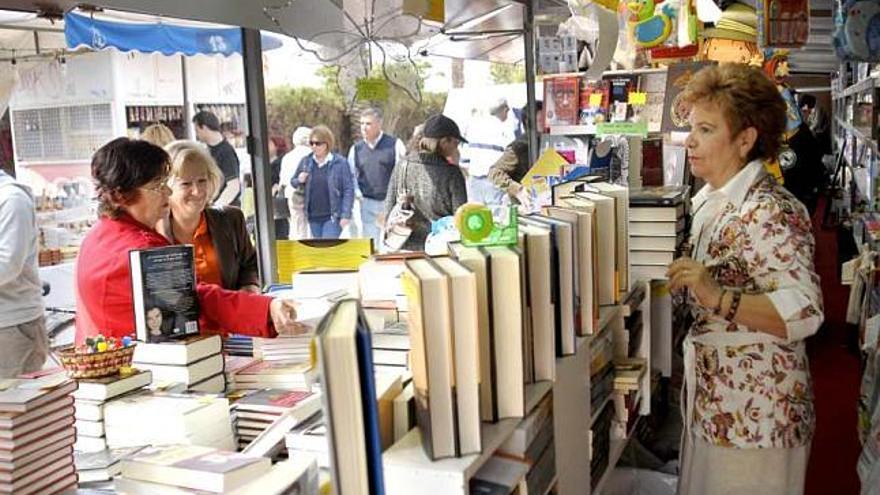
[348,108,406,246]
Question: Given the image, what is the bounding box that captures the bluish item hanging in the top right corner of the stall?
[833,0,880,62]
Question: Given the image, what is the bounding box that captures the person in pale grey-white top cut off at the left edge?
[0,170,49,378]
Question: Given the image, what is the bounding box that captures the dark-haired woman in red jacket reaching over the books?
[76,138,304,343]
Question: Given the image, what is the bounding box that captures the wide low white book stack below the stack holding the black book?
[104,392,235,450]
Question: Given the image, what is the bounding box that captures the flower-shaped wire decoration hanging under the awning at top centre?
[263,0,426,106]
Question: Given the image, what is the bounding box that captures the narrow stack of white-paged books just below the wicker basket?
[73,370,153,452]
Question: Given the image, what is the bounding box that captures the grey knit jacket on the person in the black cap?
[385,153,467,251]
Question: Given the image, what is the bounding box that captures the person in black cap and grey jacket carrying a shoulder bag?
[385,115,467,251]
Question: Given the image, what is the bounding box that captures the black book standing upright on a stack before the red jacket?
[129,245,199,342]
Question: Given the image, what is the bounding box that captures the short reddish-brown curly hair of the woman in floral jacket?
[682,63,786,161]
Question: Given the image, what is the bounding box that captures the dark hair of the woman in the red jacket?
[92,137,171,218]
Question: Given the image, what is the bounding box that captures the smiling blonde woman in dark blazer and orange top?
[156,141,260,293]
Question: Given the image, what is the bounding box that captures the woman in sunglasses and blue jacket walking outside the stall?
[290,125,354,239]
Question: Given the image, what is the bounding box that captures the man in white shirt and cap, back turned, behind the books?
[461,98,514,204]
